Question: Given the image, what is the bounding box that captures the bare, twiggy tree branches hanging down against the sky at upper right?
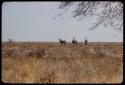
[57,1,123,31]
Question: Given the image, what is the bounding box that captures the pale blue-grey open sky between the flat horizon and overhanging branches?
[2,2,123,42]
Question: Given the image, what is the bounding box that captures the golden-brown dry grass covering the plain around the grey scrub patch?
[2,43,123,83]
